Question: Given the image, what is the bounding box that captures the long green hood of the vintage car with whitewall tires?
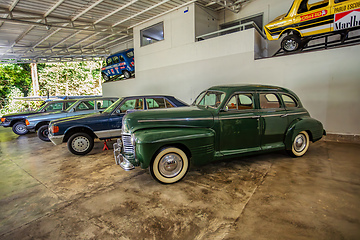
[123,106,215,133]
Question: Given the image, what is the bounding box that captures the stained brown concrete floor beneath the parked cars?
[0,127,360,240]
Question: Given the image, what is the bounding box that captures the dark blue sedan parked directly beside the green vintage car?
[49,95,188,155]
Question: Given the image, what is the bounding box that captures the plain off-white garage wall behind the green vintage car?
[103,3,360,135]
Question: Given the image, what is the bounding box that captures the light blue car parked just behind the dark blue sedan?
[25,97,118,142]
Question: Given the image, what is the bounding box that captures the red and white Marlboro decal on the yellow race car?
[334,8,360,31]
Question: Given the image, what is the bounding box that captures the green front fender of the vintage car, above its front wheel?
[134,128,215,168]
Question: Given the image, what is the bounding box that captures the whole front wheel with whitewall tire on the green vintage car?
[150,147,189,184]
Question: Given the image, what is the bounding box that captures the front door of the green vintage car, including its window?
[219,93,260,155]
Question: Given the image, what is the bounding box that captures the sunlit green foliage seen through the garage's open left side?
[0,61,102,114]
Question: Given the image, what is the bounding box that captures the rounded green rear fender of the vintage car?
[284,117,325,150]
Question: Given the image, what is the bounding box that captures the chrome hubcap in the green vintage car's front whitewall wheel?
[159,153,183,178]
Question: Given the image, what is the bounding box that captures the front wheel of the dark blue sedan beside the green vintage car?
[67,132,94,155]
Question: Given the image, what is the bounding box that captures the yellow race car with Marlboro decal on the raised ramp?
[264,0,360,52]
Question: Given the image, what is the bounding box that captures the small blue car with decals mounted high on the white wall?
[101,48,135,81]
